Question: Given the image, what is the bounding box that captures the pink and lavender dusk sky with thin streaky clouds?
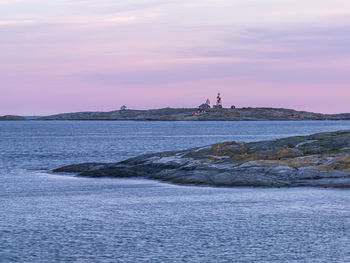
[0,0,350,115]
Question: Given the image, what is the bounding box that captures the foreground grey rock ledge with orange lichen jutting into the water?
[54,130,350,188]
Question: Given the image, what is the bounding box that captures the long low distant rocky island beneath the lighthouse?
[39,108,350,121]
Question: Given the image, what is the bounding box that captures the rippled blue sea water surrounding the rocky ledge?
[0,121,350,263]
